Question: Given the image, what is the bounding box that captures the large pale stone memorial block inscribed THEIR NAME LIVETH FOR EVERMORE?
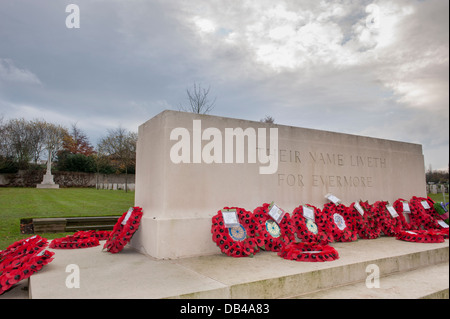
[131,111,426,258]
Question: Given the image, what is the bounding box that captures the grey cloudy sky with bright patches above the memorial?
[0,0,449,169]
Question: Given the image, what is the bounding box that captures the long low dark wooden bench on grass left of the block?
[21,216,120,234]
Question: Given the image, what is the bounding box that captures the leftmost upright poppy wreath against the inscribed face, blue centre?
[211,207,259,257]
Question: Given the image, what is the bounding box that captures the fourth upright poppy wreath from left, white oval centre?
[319,203,358,242]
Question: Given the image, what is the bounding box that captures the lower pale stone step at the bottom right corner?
[291,262,449,299]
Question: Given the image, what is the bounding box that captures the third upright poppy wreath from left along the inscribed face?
[291,205,333,245]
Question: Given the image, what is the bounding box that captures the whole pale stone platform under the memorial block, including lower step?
[13,237,449,299]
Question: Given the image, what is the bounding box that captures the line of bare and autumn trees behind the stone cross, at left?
[0,117,137,174]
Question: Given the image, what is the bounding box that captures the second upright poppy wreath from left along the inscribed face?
[253,203,295,252]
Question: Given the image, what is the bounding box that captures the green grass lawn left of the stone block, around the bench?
[0,188,134,250]
